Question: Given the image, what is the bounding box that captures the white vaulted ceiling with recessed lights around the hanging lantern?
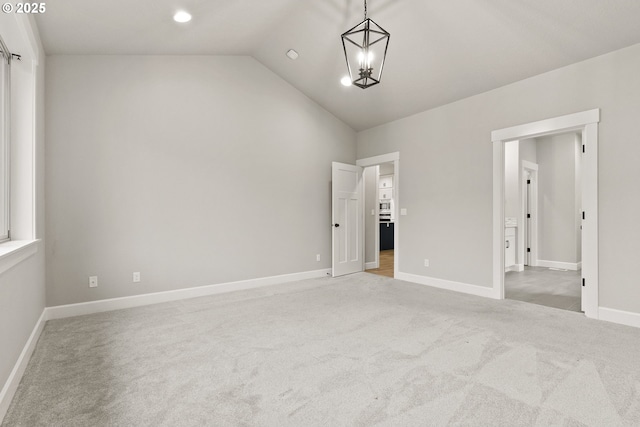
[37,0,640,130]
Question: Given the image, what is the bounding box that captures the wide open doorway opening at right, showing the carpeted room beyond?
[504,131,582,312]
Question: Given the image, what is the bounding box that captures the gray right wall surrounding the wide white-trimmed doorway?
[358,45,640,312]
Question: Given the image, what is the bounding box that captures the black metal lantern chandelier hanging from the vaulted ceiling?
[342,0,391,89]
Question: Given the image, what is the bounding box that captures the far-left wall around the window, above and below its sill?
[0,14,45,412]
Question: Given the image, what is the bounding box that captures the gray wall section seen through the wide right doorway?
[537,133,580,263]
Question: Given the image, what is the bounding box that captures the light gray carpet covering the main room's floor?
[2,273,640,426]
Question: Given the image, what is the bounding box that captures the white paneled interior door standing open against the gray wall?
[331,162,364,277]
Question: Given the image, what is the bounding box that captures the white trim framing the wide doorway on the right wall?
[491,108,600,319]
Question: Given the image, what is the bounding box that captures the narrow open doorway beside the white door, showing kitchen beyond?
[364,162,397,277]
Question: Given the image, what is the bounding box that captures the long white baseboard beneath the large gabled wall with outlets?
[46,269,331,320]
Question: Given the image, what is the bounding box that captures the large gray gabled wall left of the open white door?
[46,56,356,306]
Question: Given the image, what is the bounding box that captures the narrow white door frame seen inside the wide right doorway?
[518,160,538,271]
